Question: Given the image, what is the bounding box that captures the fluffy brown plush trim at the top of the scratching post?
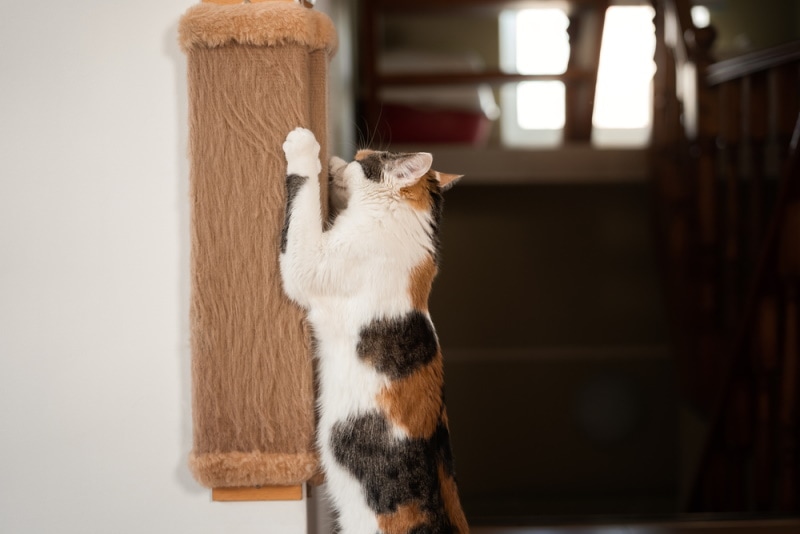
[178,2,337,56]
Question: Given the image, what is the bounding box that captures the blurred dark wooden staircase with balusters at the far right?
[650,0,800,514]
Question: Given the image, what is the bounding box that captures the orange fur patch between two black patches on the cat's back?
[378,352,444,438]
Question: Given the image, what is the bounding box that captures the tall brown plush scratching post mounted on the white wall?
[180,0,336,500]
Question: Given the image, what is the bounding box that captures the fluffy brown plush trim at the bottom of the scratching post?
[189,451,319,488]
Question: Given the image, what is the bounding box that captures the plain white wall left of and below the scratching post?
[0,0,306,534]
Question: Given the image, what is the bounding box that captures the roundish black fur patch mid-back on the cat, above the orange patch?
[357,310,439,380]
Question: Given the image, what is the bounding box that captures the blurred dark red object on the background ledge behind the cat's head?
[379,104,492,145]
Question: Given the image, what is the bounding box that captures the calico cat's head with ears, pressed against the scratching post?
[332,150,461,209]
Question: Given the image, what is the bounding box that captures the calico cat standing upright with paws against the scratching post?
[280,128,469,534]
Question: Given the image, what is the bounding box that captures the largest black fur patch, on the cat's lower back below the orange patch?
[331,413,453,533]
